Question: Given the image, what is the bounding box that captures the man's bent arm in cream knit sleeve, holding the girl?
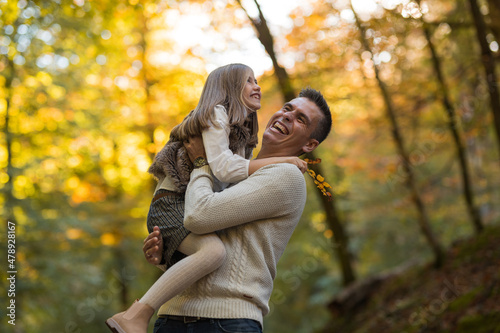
[184,164,306,234]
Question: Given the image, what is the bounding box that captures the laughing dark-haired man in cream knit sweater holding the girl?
[143,89,331,333]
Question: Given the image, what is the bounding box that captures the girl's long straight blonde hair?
[170,63,259,144]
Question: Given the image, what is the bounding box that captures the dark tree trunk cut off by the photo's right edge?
[469,0,500,161]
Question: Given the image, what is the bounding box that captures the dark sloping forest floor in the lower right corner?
[323,222,500,333]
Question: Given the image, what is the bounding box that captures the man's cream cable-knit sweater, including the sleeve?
[158,163,306,324]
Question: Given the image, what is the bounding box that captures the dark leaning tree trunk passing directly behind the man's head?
[237,0,356,286]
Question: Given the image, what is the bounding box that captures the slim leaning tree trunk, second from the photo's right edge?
[418,1,483,233]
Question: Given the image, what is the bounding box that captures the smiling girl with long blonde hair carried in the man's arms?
[106,64,306,333]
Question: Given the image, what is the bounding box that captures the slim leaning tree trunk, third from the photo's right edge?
[351,6,444,267]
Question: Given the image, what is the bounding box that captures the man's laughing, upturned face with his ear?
[262,97,323,156]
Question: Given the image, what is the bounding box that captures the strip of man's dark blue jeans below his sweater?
[153,318,262,333]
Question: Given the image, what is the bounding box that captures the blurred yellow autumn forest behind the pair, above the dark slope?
[0,0,500,333]
